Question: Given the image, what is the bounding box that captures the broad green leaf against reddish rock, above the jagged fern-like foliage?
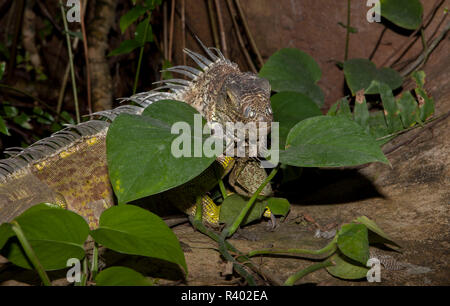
[344,58,403,95]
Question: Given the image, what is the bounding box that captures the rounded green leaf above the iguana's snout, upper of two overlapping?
[259,48,324,107]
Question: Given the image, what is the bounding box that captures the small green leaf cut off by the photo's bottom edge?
[95,267,153,286]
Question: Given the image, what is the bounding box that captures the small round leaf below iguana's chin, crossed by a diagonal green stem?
[219,194,266,225]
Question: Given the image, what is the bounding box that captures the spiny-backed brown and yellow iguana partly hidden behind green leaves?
[0,42,272,228]
